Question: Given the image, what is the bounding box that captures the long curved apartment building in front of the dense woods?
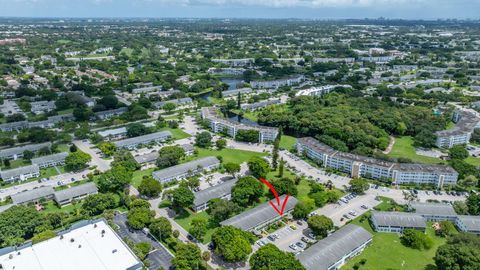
[296,137,458,188]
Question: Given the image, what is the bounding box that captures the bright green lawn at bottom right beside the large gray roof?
[342,215,446,270]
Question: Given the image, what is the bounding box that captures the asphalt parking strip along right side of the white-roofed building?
[113,214,173,269]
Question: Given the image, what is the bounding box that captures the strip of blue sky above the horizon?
[0,0,480,19]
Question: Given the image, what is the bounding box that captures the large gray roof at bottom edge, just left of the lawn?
[298,224,372,270]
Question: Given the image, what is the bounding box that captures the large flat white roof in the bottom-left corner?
[0,220,141,270]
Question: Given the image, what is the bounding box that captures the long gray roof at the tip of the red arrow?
[220,195,297,231]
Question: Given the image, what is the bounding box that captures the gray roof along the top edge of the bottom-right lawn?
[372,211,427,228]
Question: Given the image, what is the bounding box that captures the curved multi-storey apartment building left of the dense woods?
[201,107,278,143]
